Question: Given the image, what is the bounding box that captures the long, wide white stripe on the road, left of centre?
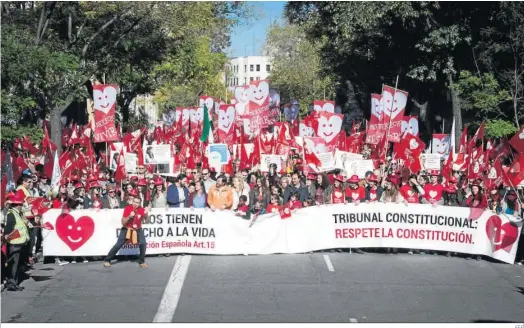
[153,255,191,323]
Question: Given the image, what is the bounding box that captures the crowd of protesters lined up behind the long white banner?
[2,146,524,290]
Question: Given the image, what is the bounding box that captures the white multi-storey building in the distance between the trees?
[224,56,271,88]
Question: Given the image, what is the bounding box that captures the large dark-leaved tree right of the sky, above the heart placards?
[286,1,512,144]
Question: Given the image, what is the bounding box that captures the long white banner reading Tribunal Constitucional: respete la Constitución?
[42,203,522,263]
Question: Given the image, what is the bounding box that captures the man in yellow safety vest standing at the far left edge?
[4,194,29,291]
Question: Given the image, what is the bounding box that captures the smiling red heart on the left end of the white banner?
[55,213,95,251]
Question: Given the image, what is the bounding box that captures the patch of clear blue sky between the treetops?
[227,1,286,57]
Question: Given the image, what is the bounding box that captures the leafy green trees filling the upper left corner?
[1,2,250,150]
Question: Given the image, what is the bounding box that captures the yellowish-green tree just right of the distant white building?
[264,24,336,112]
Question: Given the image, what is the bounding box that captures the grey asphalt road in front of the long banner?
[2,253,524,323]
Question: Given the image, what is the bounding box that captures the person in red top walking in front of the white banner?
[104,189,151,269]
